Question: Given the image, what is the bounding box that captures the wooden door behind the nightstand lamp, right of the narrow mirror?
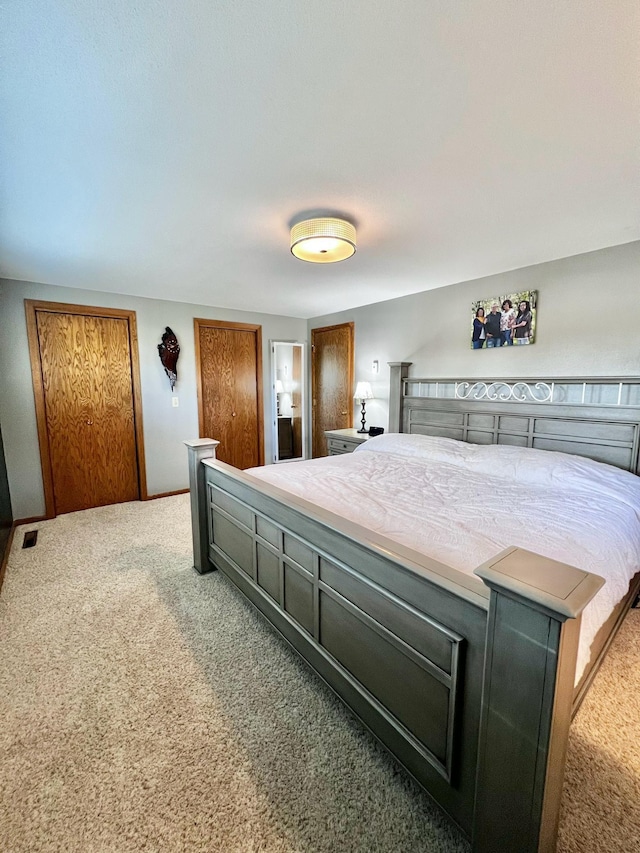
[311,323,354,459]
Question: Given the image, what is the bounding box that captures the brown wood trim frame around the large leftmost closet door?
[24,299,148,518]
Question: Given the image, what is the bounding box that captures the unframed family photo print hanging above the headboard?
[471,290,538,349]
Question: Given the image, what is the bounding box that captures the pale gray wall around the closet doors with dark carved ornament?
[0,280,307,518]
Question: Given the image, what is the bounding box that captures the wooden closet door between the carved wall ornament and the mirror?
[194,319,264,468]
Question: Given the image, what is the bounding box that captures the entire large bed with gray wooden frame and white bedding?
[187,362,640,851]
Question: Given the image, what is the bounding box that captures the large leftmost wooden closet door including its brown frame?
[26,300,146,515]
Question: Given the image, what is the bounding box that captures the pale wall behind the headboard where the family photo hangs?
[309,242,640,427]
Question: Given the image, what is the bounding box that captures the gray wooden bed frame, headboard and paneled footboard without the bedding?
[186,362,640,853]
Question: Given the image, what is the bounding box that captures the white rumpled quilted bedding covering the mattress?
[248,434,640,683]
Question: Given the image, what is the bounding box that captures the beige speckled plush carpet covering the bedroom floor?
[0,495,640,853]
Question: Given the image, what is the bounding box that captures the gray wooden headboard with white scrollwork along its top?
[389,362,640,474]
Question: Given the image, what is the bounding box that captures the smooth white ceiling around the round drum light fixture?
[0,0,640,317]
